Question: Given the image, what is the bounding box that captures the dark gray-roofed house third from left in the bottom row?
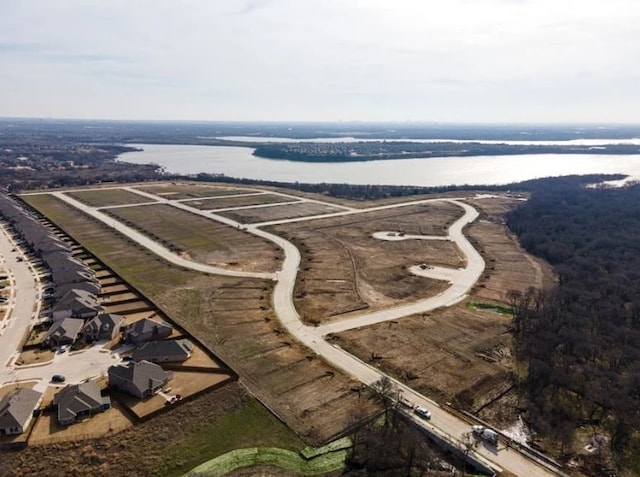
[109,361,173,399]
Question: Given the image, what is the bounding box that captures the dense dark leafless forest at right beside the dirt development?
[507,179,640,475]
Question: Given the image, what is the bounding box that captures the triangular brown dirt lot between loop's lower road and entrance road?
[334,304,510,409]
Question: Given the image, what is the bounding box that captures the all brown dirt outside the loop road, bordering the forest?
[332,195,551,417]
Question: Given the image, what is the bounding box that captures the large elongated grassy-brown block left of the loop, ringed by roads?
[104,205,281,272]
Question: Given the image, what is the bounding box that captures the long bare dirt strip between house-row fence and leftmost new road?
[21,195,375,444]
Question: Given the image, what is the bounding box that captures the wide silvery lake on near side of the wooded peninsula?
[119,144,640,186]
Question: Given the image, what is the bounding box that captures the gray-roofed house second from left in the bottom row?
[53,381,111,426]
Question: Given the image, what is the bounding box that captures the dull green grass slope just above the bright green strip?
[156,398,303,476]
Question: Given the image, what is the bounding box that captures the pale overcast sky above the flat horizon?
[0,0,640,123]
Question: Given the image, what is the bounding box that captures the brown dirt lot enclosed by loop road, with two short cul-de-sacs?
[272,203,464,323]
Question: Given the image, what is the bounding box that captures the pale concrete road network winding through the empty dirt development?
[10,187,562,476]
